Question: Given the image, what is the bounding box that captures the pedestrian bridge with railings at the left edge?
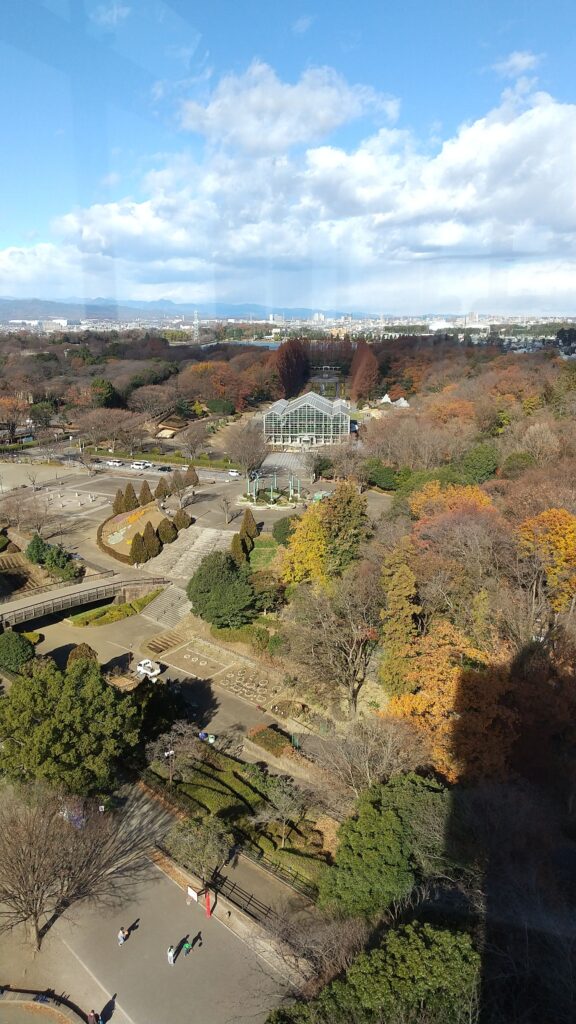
[0,569,170,629]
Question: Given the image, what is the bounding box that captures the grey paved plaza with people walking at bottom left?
[0,869,286,1024]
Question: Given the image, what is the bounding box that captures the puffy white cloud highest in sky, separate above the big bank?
[180,60,399,153]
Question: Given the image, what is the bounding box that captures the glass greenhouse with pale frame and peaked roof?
[263,391,351,445]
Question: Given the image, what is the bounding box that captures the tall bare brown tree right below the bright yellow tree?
[290,563,381,715]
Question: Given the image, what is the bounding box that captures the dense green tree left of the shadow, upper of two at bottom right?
[320,775,451,918]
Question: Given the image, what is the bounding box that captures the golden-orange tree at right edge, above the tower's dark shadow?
[519,509,576,612]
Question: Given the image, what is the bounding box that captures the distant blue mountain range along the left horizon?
[0,297,358,321]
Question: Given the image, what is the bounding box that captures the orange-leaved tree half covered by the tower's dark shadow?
[385,620,516,782]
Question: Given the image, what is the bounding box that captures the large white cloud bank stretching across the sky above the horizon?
[0,66,576,312]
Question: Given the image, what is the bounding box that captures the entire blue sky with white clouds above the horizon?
[0,0,576,315]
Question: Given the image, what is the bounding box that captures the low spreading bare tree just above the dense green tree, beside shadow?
[303,718,428,797]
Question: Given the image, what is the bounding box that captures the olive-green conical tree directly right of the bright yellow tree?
[320,481,368,577]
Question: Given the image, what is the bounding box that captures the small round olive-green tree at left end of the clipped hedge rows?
[166,816,234,885]
